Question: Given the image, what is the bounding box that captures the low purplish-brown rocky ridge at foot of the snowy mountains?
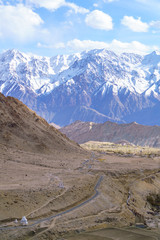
[60,121,160,147]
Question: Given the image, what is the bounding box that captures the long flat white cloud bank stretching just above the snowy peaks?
[48,39,158,55]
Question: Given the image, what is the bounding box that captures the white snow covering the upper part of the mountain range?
[0,49,160,98]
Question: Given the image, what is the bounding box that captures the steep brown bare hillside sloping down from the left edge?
[0,93,82,154]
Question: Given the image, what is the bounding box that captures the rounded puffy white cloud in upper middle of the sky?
[85,10,113,31]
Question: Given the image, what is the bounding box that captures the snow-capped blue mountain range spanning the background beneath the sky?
[0,49,160,125]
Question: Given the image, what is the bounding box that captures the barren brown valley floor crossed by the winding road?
[0,143,160,240]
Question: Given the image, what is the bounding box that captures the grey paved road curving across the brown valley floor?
[0,176,103,231]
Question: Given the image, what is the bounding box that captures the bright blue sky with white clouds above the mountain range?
[0,0,160,56]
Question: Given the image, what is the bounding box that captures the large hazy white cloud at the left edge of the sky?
[0,4,45,42]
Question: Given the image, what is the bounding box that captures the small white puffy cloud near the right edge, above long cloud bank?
[121,16,149,32]
